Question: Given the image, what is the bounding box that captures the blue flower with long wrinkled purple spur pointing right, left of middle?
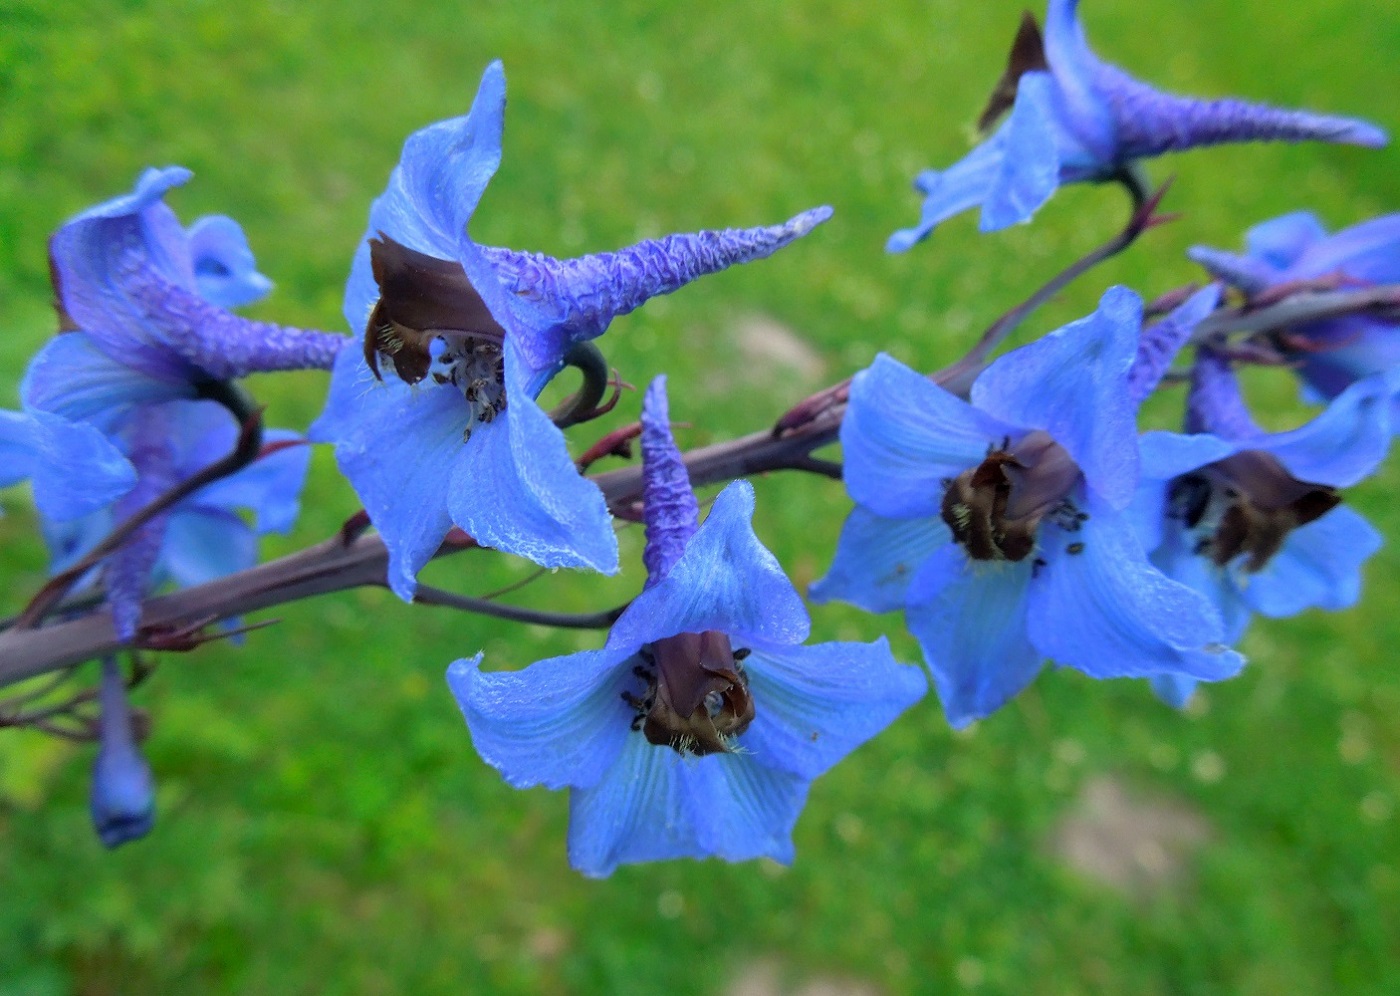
[311,63,830,598]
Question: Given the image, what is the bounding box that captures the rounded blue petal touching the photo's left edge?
[0,410,136,521]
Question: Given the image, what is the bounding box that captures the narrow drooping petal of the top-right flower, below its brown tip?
[980,73,1060,231]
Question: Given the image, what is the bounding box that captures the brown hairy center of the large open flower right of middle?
[939,430,1081,560]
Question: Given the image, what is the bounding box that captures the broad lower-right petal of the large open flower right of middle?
[1026,496,1245,681]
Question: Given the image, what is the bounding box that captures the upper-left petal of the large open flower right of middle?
[841,353,1021,518]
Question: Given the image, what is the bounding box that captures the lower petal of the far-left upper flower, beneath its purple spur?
[20,332,195,434]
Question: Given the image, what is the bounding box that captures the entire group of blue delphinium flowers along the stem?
[0,0,1400,876]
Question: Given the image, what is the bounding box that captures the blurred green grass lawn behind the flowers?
[0,0,1400,995]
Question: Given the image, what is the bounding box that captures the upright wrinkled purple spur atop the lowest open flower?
[641,374,700,588]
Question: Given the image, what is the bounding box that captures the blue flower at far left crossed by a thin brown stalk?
[39,401,311,639]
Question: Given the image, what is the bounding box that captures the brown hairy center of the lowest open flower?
[622,629,753,756]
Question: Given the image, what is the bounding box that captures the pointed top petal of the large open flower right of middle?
[972,287,1142,509]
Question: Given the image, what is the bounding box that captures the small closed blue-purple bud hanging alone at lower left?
[90,657,155,848]
